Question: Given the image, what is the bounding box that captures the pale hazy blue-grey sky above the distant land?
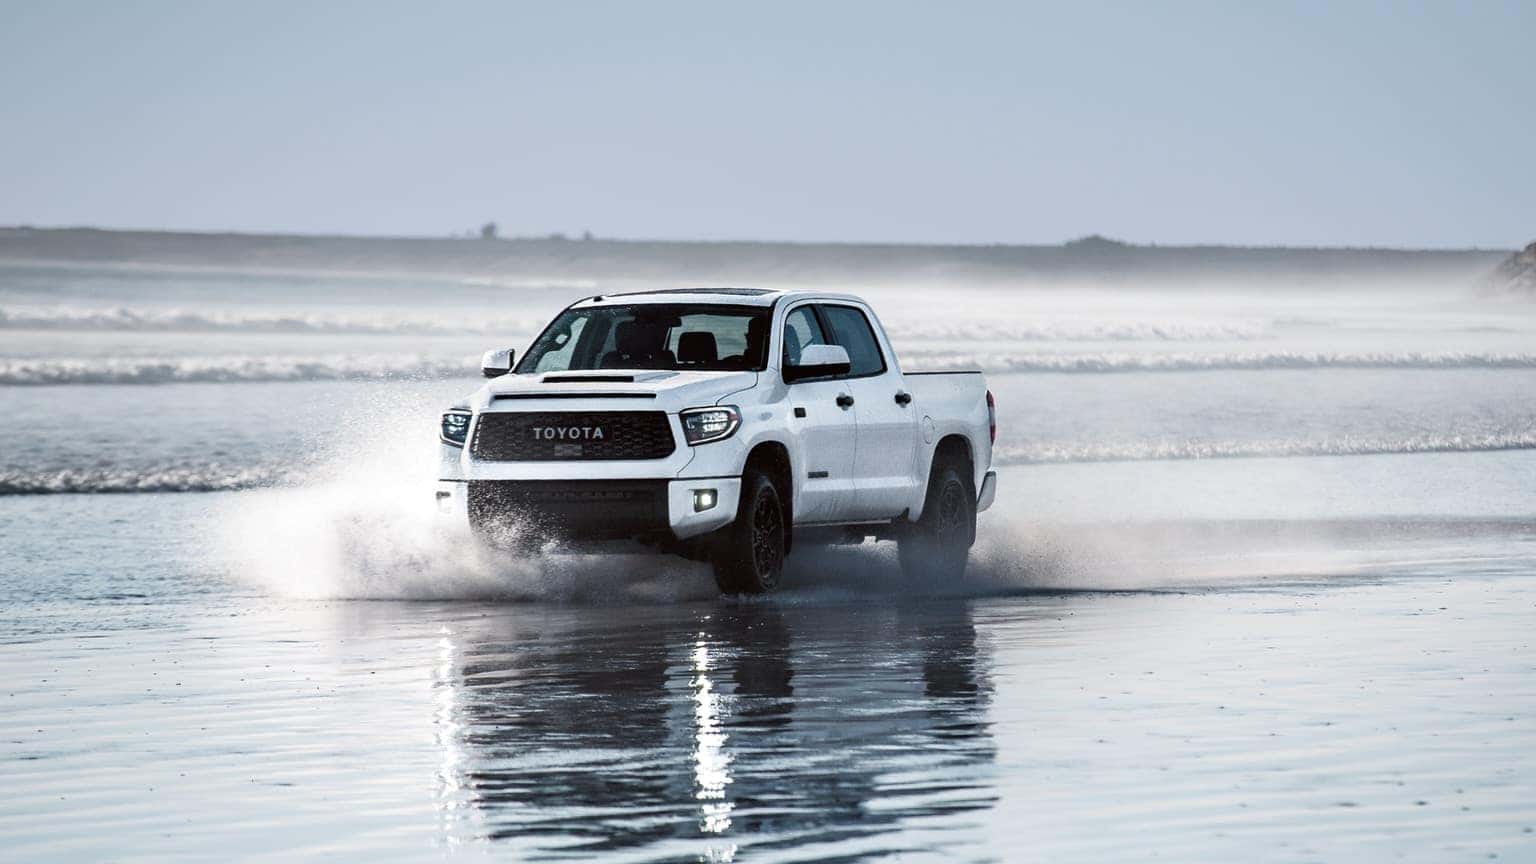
[0,0,1536,246]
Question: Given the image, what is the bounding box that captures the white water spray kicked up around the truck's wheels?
[215,379,1394,603]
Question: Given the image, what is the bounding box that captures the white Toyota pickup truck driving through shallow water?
[436,289,997,593]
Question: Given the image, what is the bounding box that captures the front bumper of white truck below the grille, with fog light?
[436,477,742,541]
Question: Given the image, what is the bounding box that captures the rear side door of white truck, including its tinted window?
[817,303,917,520]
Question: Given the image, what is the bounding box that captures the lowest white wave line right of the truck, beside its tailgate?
[994,429,1536,464]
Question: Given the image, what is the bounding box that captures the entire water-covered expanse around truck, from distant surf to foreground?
[0,264,1536,861]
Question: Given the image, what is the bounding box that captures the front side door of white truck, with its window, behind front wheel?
[779,304,856,524]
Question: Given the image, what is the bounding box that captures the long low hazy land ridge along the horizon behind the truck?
[0,226,1511,284]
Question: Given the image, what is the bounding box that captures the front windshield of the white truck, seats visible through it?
[518,303,773,372]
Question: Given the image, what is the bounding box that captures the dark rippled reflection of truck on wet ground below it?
[436,598,998,861]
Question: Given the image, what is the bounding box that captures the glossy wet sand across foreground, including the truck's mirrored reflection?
[0,495,1536,861]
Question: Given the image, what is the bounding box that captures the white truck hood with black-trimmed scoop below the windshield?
[472,369,757,414]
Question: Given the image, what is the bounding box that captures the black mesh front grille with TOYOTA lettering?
[470,410,677,463]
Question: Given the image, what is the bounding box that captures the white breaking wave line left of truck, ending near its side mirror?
[0,354,478,386]
